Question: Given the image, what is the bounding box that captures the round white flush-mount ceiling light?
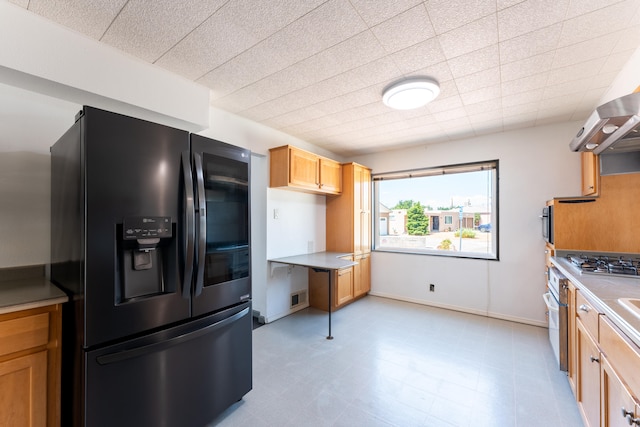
[382,77,440,110]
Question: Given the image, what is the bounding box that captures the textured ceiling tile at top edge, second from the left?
[101,0,224,62]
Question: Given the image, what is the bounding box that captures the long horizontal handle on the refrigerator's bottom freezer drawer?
[96,307,250,365]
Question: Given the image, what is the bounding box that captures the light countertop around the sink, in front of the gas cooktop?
[551,257,640,347]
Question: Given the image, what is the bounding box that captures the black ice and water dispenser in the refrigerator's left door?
[116,216,174,303]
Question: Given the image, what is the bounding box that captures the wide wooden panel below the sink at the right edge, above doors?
[600,316,640,396]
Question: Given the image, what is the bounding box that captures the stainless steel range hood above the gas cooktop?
[569,92,640,154]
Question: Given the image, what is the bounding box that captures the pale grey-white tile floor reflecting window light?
[212,296,582,427]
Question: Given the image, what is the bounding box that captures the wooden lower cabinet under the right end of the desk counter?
[309,267,353,311]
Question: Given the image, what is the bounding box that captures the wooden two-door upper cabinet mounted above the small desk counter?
[269,145,342,194]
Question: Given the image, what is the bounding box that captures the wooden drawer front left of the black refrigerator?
[0,313,49,356]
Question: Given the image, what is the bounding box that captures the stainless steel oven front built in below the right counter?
[543,267,569,371]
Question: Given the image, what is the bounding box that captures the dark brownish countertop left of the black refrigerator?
[0,277,68,314]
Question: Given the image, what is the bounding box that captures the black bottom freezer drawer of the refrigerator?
[85,302,252,427]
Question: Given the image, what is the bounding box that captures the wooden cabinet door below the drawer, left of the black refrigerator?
[0,350,47,427]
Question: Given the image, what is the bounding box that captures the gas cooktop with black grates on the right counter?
[566,253,640,278]
